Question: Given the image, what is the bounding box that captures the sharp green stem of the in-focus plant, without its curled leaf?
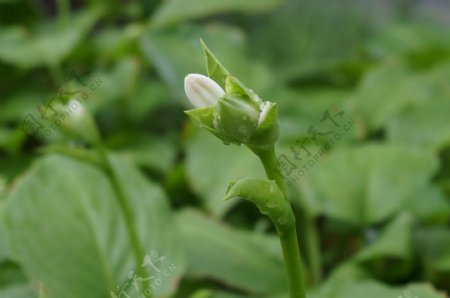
[249,146,306,298]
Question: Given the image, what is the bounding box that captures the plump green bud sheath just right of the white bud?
[214,95,259,143]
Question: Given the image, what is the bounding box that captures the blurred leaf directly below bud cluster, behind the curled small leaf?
[187,131,265,216]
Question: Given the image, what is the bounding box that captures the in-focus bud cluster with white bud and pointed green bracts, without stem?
[184,44,279,147]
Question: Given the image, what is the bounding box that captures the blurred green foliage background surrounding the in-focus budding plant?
[0,0,450,298]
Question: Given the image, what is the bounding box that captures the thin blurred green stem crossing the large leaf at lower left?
[95,143,152,298]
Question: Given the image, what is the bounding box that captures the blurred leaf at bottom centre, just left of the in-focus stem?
[177,210,287,297]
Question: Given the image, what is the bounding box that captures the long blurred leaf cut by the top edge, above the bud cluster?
[152,0,281,27]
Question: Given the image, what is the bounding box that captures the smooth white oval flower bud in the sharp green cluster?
[184,73,225,108]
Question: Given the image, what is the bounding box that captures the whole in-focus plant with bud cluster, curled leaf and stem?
[185,42,306,298]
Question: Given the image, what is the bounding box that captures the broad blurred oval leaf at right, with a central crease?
[294,145,437,225]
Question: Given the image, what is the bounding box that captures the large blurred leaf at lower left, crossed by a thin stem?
[5,156,183,298]
